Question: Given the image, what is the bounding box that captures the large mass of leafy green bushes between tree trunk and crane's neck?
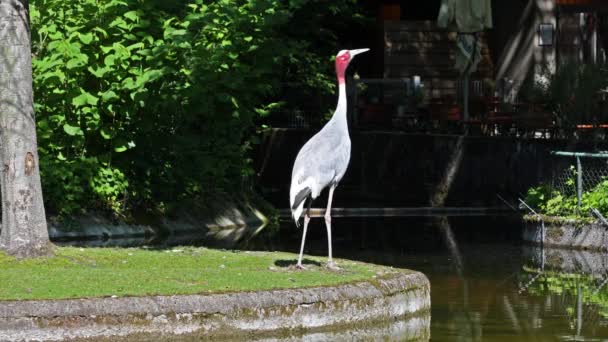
[30,0,366,215]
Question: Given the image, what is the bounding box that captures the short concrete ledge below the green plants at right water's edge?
[523,217,608,251]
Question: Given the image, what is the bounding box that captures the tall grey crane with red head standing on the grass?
[289,49,369,269]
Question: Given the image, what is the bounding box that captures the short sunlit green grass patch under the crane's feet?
[0,247,394,300]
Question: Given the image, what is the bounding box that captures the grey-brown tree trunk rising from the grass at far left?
[0,0,52,257]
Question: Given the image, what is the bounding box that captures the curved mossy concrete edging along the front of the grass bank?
[0,271,431,341]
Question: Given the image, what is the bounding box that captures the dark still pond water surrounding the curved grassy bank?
[60,217,608,341]
